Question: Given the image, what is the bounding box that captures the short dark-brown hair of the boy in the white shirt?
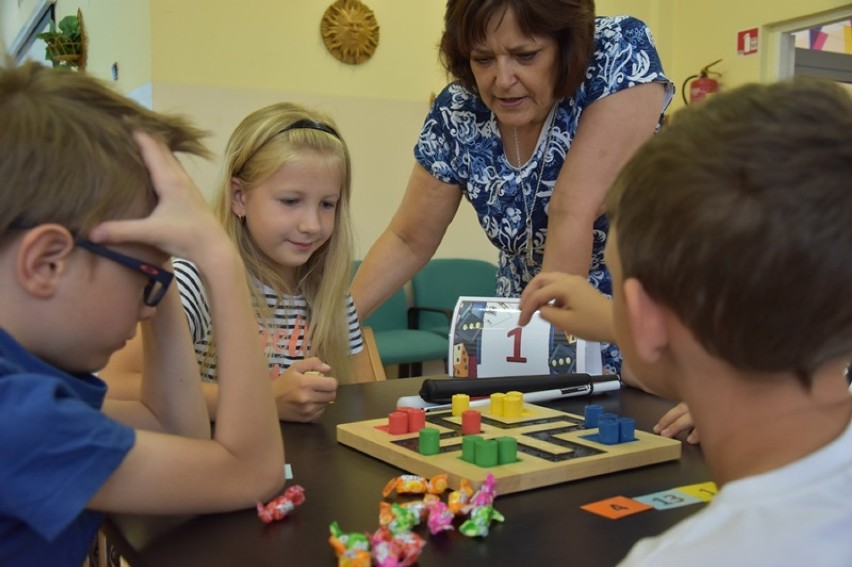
[607,81,852,383]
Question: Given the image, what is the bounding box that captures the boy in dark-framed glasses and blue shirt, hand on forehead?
[0,64,284,565]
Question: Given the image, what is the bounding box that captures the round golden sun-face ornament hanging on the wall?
[320,0,379,65]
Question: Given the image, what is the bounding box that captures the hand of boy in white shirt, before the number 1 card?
[518,272,615,342]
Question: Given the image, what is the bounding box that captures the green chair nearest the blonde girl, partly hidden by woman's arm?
[353,261,449,378]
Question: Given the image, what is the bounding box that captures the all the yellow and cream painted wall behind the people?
[0,0,852,261]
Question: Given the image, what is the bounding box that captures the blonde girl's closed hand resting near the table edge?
[272,357,337,422]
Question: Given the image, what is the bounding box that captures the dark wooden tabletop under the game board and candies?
[105,378,710,567]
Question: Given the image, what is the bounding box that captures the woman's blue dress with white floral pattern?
[414,16,674,372]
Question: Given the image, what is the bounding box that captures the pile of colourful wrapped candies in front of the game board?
[329,473,504,567]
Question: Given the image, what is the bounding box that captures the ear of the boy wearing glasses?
[15,224,74,299]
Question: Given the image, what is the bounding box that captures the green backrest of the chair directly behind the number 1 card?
[411,258,497,336]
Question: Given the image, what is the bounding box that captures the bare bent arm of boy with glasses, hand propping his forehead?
[89,135,284,513]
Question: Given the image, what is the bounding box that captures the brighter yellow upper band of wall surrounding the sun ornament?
[151,0,445,101]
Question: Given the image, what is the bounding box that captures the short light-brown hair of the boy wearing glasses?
[0,62,206,238]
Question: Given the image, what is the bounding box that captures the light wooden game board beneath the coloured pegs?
[337,404,681,494]
